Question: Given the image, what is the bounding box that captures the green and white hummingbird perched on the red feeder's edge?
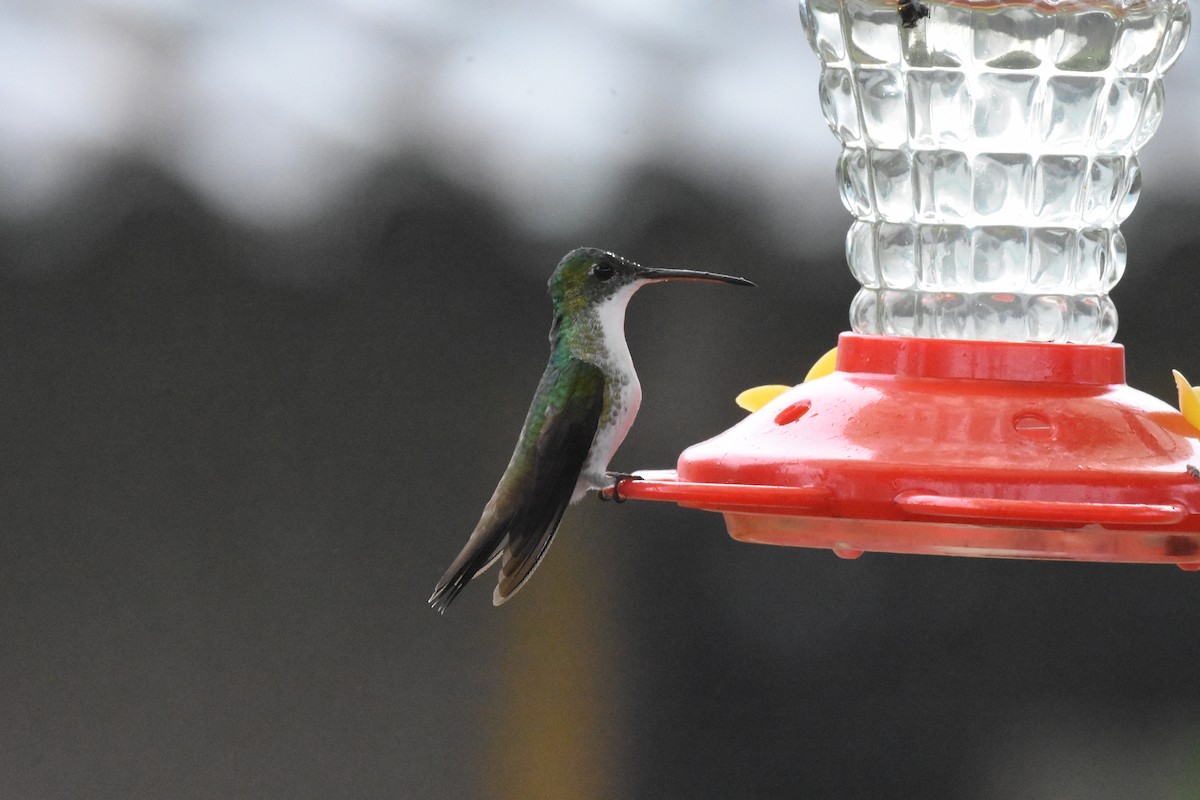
[430,247,755,612]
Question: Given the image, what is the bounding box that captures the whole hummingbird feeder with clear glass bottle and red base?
[618,0,1200,570]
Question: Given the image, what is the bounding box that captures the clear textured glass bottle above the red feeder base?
[800,0,1189,343]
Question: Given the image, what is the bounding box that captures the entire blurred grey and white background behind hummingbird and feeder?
[7,0,1200,800]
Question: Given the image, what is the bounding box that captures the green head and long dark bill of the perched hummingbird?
[550,247,754,318]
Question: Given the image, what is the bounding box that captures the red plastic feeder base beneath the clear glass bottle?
[620,333,1200,570]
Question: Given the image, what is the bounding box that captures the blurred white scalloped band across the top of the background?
[0,0,1200,242]
